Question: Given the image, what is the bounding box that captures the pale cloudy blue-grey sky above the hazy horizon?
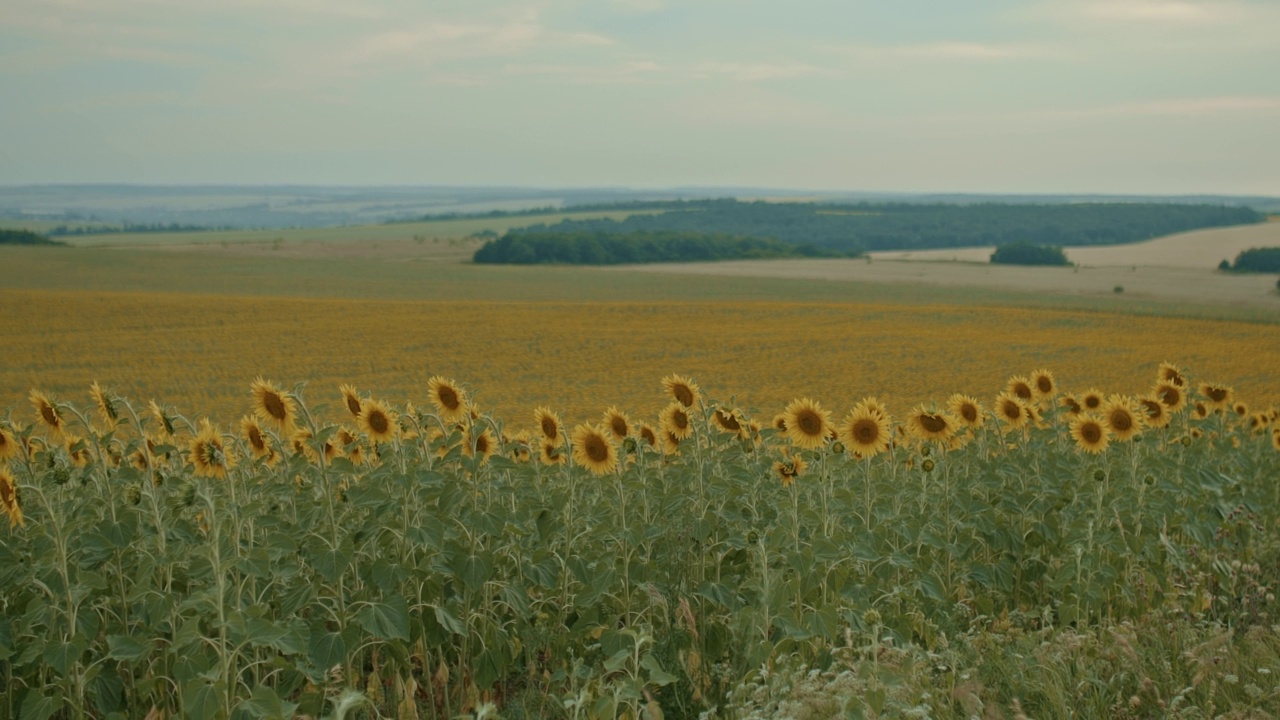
[0,0,1280,196]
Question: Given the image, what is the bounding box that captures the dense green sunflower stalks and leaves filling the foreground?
[0,368,1280,719]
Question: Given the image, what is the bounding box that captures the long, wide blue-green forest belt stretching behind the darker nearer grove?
[496,200,1265,252]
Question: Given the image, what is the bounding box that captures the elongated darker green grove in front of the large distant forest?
[474,231,856,265]
